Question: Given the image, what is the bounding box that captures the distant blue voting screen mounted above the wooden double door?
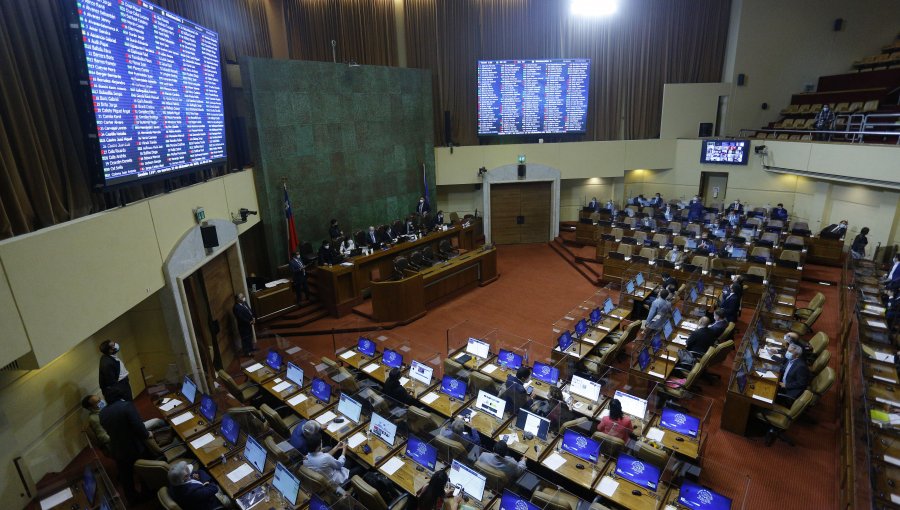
[478,58,591,136]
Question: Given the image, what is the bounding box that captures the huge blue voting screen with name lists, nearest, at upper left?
[70,0,226,187]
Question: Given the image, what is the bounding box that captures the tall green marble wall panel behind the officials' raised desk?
[241,58,436,267]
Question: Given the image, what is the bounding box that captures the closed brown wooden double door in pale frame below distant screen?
[490,181,552,244]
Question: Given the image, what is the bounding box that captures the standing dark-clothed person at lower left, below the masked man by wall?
[100,398,151,504]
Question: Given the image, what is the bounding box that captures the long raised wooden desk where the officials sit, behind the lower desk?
[316,224,476,317]
